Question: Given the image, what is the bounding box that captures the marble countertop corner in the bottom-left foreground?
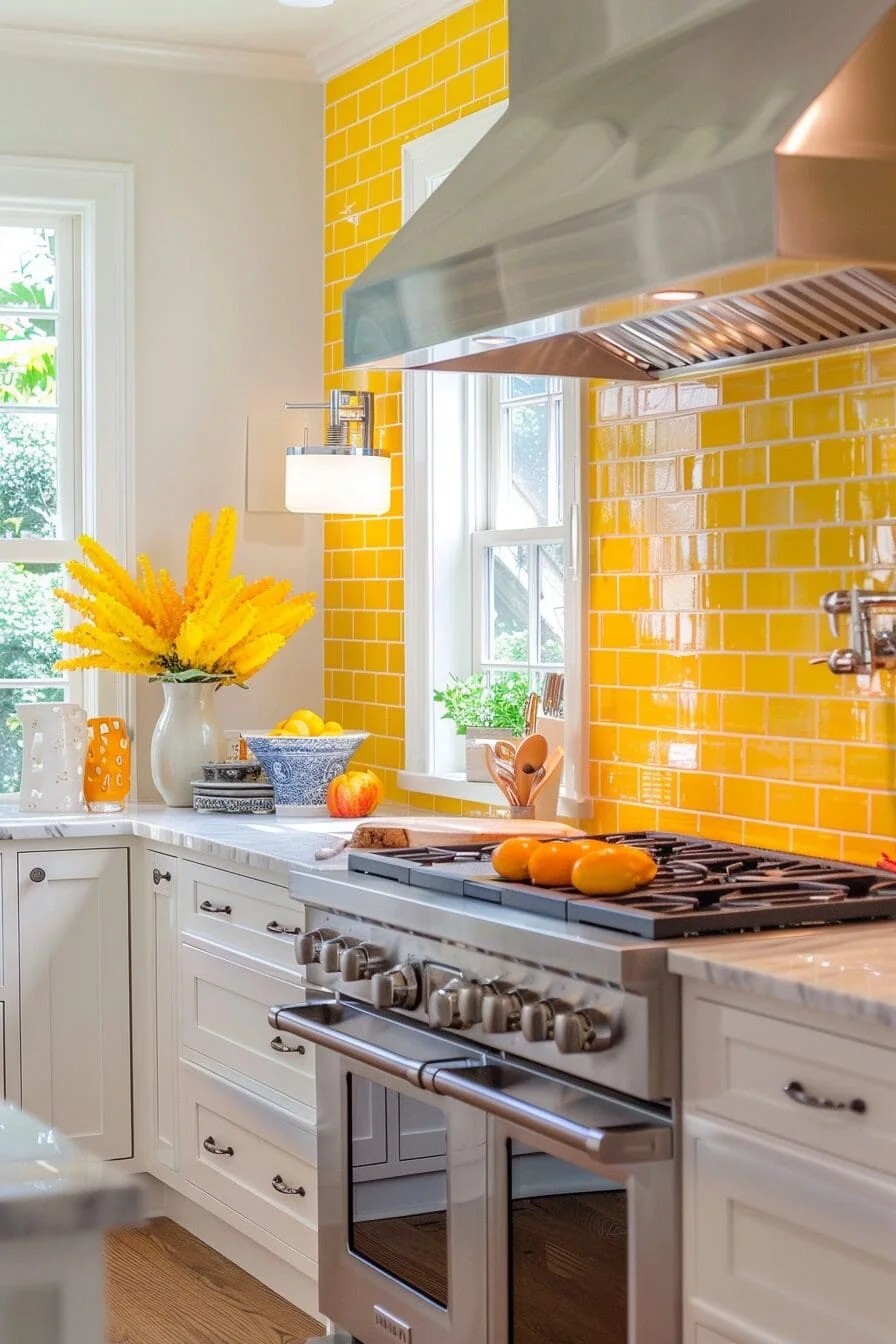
[0,1102,144,1242]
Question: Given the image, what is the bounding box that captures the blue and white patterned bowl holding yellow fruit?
[246,732,369,817]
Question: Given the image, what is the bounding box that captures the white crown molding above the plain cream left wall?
[0,25,315,83]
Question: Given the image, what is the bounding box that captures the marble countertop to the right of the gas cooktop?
[669,919,896,1027]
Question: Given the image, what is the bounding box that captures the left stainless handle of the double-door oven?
[267,995,485,1091]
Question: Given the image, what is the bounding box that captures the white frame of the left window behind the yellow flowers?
[0,156,136,800]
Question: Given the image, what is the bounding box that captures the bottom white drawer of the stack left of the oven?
[180,1066,317,1262]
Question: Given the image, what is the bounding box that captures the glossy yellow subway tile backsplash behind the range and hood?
[324,0,896,838]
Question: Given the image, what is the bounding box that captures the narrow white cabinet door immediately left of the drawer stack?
[142,851,177,1171]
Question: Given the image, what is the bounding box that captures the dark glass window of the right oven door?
[505,1138,629,1344]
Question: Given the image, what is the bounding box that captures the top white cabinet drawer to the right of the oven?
[684,993,896,1173]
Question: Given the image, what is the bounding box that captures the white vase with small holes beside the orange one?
[16,703,87,812]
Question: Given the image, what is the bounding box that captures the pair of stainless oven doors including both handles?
[270,1000,681,1344]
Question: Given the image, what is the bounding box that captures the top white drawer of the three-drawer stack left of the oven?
[177,863,302,974]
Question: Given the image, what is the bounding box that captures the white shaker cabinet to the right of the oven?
[682,980,896,1344]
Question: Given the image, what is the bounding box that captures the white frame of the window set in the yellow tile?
[399,103,594,820]
